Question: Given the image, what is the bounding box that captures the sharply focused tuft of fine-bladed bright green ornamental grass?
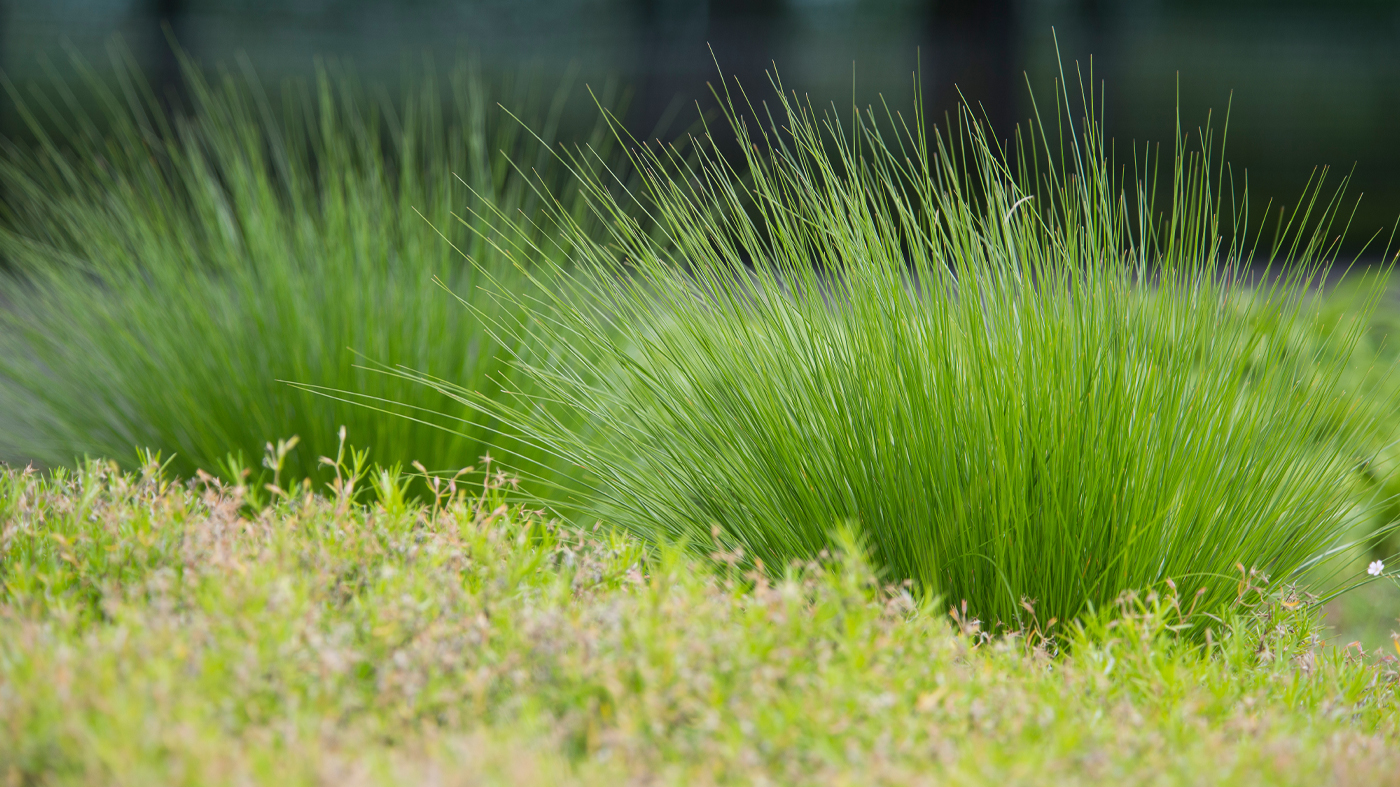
[438,65,1388,626]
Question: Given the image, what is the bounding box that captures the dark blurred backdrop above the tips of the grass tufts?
[8,0,1400,245]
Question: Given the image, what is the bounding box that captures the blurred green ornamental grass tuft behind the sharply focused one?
[0,47,605,492]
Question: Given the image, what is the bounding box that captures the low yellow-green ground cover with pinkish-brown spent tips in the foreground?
[0,464,1400,784]
